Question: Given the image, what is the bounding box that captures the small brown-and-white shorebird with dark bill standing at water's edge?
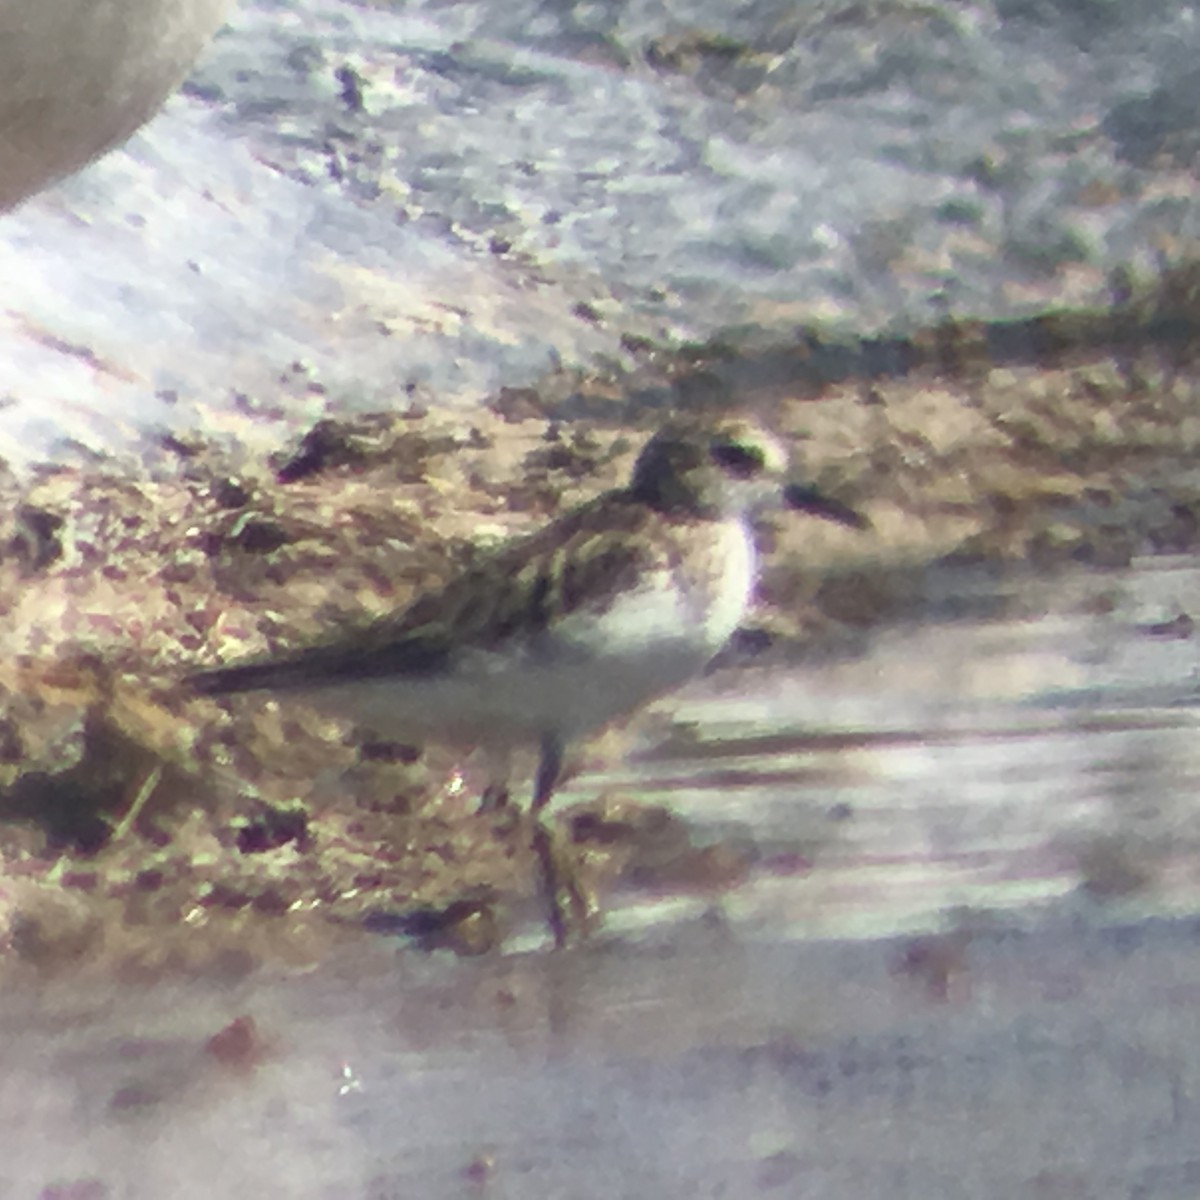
[188,419,865,943]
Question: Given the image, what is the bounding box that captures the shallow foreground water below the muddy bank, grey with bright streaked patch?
[11,559,1200,1200]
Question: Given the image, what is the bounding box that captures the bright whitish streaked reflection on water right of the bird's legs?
[559,559,1200,938]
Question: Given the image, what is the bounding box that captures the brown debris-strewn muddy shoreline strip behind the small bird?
[7,297,1200,976]
